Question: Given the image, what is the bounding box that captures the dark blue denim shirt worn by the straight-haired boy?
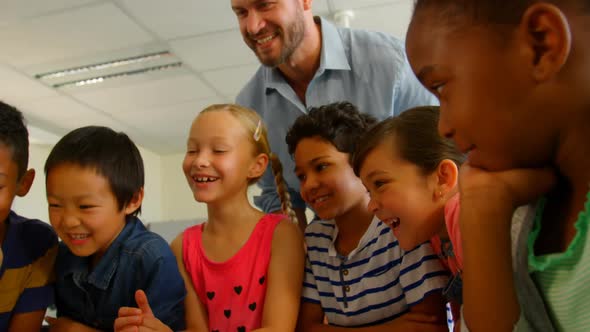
[56,217,186,331]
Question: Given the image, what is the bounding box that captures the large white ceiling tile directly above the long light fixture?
[0,3,152,68]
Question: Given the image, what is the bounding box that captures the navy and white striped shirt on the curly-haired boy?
[302,218,448,327]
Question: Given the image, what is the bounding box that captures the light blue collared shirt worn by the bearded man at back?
[236,18,438,212]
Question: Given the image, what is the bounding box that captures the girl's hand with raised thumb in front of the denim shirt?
[114,290,172,332]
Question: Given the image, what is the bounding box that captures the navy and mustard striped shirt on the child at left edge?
[0,211,57,331]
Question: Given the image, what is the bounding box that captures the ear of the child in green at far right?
[520,2,572,82]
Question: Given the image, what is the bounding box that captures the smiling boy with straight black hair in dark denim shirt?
[45,126,186,331]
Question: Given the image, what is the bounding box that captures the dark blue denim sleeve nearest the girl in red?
[143,239,186,331]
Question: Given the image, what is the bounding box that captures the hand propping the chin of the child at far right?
[459,163,557,217]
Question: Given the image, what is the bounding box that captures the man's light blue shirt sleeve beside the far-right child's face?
[393,55,439,116]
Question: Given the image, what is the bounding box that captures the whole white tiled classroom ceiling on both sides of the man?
[0,0,412,155]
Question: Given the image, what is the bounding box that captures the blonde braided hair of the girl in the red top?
[200,104,297,224]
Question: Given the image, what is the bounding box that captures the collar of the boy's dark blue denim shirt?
[63,216,143,290]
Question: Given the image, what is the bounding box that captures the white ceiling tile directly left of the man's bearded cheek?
[170,29,258,71]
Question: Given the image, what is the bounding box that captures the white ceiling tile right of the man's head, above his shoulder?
[351,1,413,39]
